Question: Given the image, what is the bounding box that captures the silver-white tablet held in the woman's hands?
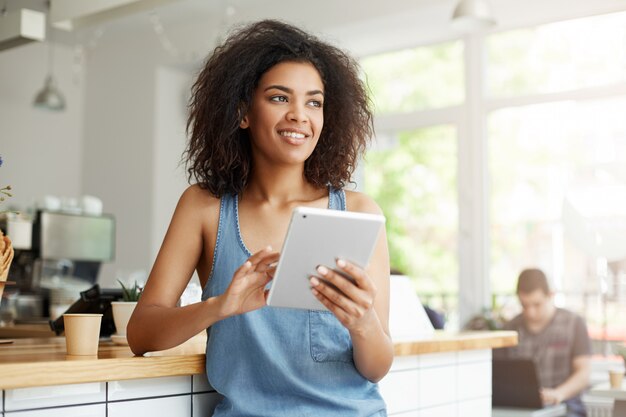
[267,207,385,310]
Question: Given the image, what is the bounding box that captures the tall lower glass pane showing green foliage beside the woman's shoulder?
[363,126,458,312]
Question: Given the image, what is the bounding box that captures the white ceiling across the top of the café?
[0,0,626,55]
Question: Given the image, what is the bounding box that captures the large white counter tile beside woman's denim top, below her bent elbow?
[378,369,421,414]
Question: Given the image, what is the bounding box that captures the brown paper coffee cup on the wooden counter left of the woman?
[63,314,102,356]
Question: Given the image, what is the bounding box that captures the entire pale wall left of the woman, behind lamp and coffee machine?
[0,24,196,287]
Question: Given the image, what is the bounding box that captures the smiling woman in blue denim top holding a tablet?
[127,21,393,416]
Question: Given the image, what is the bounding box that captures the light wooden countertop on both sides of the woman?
[0,331,517,389]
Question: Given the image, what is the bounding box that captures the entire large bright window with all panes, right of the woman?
[362,12,626,337]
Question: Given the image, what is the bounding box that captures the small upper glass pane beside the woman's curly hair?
[361,41,464,114]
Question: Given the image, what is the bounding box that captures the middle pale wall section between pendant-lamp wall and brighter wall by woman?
[82,34,155,287]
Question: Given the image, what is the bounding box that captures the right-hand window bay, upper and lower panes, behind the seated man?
[486,13,626,338]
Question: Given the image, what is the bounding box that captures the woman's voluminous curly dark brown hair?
[183,20,373,197]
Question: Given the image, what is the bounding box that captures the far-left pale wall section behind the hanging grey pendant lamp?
[0,43,84,209]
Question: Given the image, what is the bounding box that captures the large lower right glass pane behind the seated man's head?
[489,98,626,337]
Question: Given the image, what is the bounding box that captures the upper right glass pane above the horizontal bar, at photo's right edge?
[486,12,626,97]
